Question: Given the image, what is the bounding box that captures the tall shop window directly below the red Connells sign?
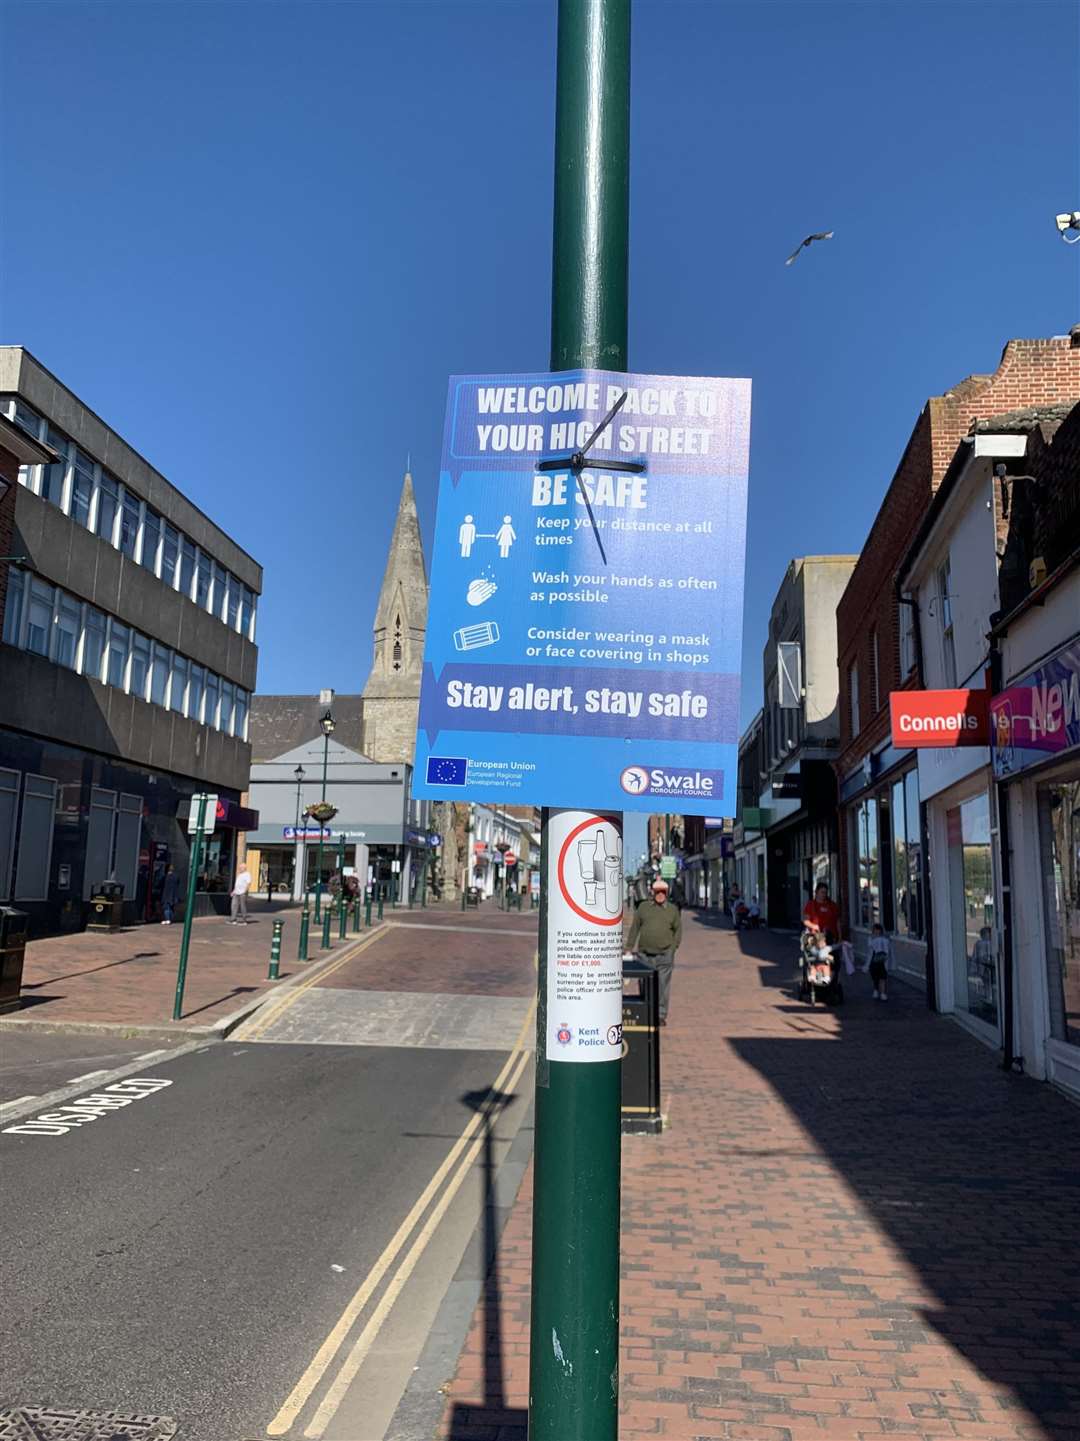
[946,791,998,1026]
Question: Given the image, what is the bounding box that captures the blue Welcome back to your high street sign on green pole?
[412,370,750,816]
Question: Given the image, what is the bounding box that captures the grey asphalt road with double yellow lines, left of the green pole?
[0,931,535,1441]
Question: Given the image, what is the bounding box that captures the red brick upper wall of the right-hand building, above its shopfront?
[836,336,1080,774]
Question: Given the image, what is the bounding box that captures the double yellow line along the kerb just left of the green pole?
[267,997,536,1441]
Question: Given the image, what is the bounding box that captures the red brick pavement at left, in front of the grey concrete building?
[4,901,325,1029]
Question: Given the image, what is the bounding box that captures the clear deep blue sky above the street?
[0,0,1080,755]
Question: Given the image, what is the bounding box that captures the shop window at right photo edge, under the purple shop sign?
[1038,780,1080,1046]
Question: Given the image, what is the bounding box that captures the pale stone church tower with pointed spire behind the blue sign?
[363,471,428,765]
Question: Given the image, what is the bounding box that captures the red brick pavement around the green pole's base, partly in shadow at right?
[443,912,1080,1441]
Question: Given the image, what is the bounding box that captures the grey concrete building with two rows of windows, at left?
[0,354,262,929]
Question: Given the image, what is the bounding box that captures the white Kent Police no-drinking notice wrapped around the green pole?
[546,810,623,1062]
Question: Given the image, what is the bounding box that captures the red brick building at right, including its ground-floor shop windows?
[836,333,1080,984]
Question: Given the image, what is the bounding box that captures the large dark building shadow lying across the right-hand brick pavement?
[730,934,1080,1441]
